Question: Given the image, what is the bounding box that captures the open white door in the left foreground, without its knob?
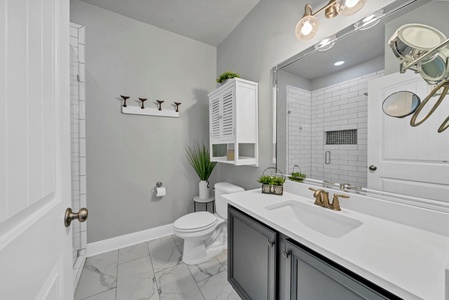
[0,0,73,300]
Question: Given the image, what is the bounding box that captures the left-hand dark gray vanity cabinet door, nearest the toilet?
[228,206,277,300]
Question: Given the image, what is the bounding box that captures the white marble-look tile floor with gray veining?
[75,236,240,300]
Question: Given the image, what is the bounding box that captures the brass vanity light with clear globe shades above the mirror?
[295,0,367,41]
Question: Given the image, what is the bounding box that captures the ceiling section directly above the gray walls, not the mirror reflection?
[81,0,260,47]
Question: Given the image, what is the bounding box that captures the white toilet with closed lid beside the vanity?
[173,182,244,265]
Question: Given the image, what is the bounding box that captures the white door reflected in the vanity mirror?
[367,72,449,202]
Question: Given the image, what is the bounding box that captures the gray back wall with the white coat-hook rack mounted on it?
[71,0,217,243]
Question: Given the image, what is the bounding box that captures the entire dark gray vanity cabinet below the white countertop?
[228,205,401,300]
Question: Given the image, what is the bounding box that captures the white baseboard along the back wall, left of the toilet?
[86,224,173,257]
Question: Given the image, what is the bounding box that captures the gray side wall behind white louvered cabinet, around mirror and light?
[217,0,393,188]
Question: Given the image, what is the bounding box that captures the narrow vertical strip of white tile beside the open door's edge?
[70,23,87,287]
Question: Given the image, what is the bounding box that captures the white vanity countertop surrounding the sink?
[225,189,449,300]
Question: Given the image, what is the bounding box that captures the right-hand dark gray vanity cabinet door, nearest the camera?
[280,238,400,300]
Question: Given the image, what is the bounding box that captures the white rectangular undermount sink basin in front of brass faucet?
[265,200,363,238]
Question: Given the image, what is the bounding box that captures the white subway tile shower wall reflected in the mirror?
[286,71,384,187]
